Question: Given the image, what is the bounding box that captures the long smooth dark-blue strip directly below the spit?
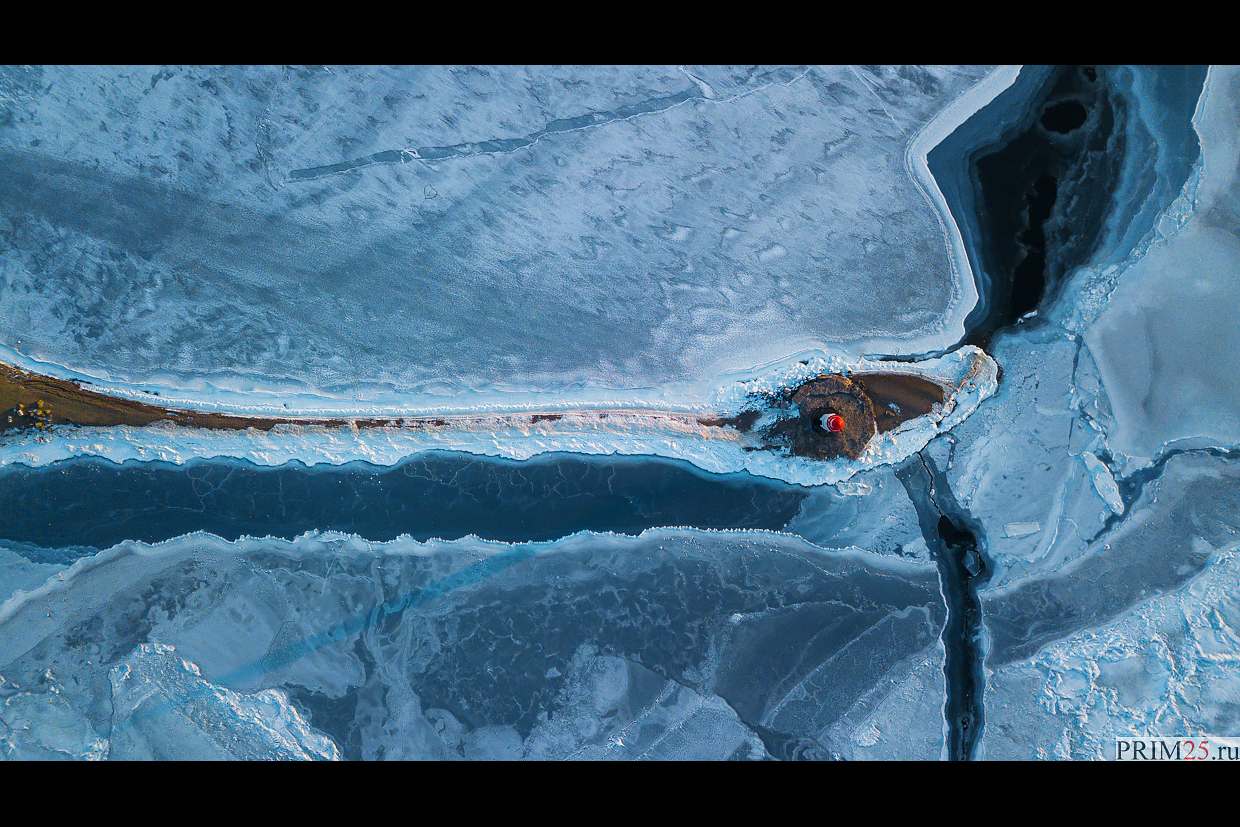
[0,454,807,559]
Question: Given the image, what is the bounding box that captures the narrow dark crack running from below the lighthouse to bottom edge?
[895,454,990,761]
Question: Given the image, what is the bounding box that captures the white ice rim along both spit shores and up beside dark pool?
[0,67,1019,486]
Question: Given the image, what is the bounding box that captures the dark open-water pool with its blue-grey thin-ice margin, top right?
[928,66,1205,348]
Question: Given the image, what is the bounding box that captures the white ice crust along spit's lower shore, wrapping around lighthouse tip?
[0,347,998,486]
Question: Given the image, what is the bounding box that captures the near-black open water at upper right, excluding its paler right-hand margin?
[868,66,1125,361]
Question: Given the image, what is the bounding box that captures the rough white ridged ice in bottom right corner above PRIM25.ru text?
[985,543,1240,759]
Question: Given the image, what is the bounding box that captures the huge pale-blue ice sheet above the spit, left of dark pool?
[0,66,985,396]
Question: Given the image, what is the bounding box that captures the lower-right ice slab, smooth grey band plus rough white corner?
[983,454,1240,759]
